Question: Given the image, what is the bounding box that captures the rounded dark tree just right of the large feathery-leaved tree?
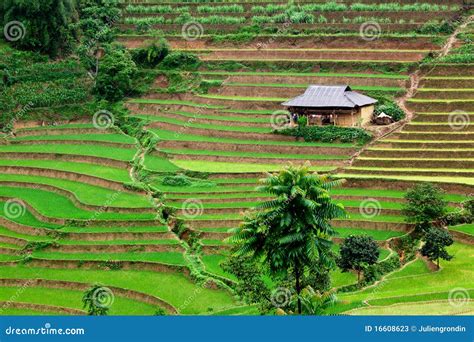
[337,235,380,281]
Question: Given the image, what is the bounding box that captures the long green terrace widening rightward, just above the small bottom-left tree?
[0,265,237,314]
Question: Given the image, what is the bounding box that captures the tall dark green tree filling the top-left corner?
[0,0,78,57]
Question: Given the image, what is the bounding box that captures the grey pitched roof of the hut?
[282,85,377,108]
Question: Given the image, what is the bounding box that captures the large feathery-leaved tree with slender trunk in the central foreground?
[230,164,346,313]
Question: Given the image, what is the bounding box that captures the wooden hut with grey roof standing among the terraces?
[282,85,377,127]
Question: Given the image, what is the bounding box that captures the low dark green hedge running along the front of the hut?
[275,126,372,144]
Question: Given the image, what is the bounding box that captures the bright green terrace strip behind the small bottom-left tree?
[0,286,157,315]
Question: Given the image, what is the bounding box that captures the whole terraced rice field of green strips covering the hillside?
[0,0,474,315]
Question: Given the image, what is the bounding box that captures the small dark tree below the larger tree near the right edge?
[421,227,454,269]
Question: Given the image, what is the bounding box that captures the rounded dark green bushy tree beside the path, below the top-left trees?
[94,49,137,102]
